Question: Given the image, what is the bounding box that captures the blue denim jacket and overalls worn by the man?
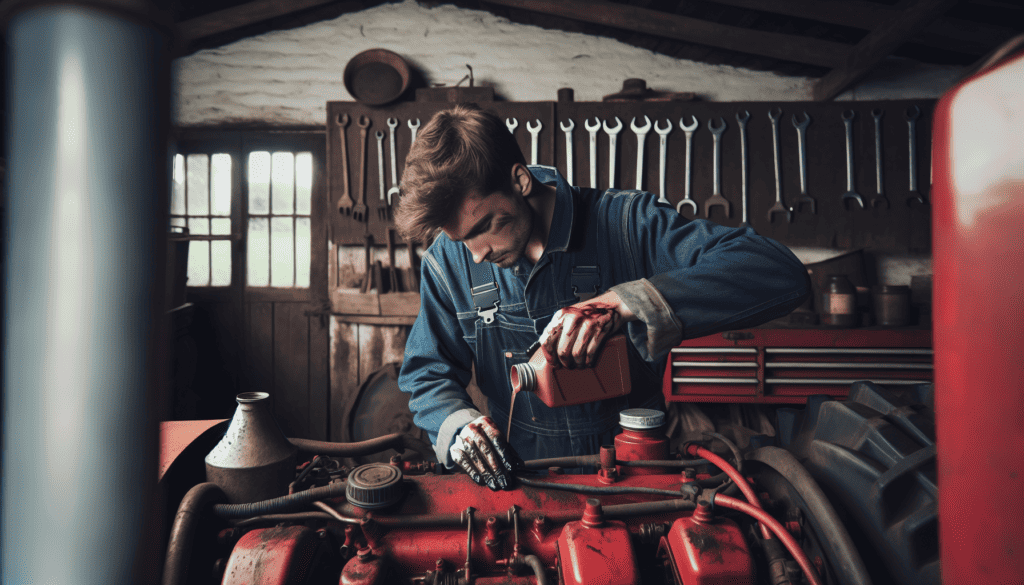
[398,166,810,467]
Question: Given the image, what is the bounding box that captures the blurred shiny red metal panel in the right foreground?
[931,55,1024,583]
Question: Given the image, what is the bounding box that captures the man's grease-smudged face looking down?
[443,187,534,268]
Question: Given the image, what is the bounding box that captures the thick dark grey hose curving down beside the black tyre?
[746,447,871,585]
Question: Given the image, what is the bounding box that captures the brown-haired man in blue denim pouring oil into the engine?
[395,106,810,490]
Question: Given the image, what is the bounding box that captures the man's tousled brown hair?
[394,103,526,242]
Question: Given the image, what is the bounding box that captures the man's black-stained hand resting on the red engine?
[449,416,522,492]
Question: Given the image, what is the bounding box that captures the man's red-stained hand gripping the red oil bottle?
[541,291,637,368]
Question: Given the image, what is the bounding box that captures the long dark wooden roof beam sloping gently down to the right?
[483,0,850,68]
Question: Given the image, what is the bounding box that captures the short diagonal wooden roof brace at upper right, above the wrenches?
[813,0,956,101]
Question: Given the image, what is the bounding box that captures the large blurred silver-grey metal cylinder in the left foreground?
[0,5,170,584]
